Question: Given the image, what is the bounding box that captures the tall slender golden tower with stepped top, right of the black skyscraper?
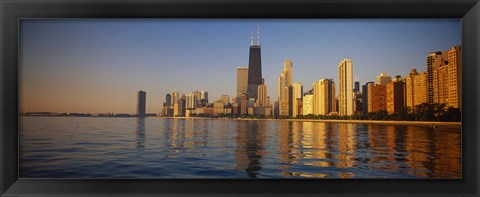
[278,59,293,116]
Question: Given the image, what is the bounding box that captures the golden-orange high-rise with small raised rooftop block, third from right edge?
[405,69,427,112]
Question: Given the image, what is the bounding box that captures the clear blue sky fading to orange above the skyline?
[19,19,461,114]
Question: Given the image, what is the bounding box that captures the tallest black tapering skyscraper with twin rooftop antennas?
[247,28,262,100]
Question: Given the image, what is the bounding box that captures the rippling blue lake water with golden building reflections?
[19,117,461,179]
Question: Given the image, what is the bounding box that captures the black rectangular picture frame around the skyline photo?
[0,0,480,197]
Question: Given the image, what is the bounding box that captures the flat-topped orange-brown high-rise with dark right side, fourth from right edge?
[386,76,406,114]
